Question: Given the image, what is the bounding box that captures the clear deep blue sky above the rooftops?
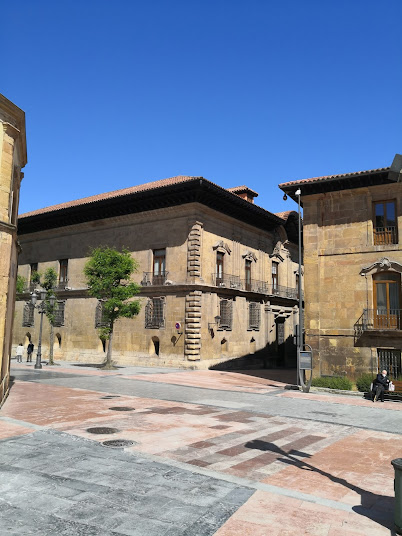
[0,0,402,213]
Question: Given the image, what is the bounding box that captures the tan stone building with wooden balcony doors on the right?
[279,155,402,377]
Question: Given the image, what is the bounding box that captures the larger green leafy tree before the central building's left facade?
[84,246,141,369]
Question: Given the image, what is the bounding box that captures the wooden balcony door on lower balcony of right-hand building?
[373,272,401,329]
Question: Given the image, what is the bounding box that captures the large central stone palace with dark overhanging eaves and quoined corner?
[14,176,298,368]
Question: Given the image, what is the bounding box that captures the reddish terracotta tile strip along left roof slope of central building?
[19,175,203,218]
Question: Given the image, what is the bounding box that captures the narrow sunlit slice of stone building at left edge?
[0,95,27,406]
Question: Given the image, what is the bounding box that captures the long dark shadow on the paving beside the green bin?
[245,439,397,536]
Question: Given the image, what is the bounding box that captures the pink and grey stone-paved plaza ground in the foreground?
[0,364,402,536]
